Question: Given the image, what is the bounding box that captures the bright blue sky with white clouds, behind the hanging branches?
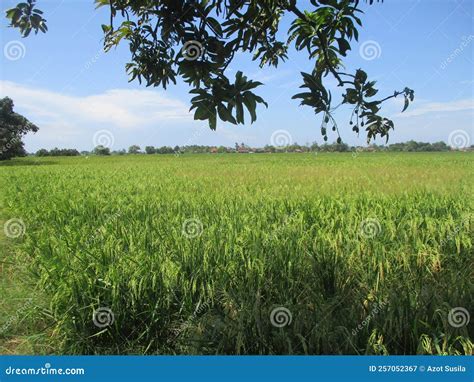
[0,0,474,151]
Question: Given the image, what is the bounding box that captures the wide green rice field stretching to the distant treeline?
[0,153,474,354]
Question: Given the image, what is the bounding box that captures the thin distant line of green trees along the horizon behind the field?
[36,141,474,157]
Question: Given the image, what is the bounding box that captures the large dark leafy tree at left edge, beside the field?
[0,97,38,160]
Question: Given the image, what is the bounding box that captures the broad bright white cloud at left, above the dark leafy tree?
[0,81,192,129]
